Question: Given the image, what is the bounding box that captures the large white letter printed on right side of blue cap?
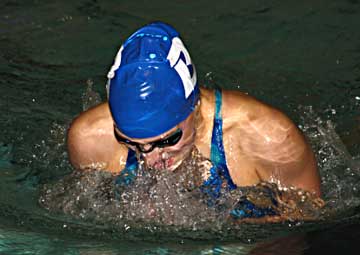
[167,37,196,98]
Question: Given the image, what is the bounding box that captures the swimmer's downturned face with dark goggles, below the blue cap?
[115,113,195,171]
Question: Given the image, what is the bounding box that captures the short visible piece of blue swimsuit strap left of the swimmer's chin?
[115,149,139,185]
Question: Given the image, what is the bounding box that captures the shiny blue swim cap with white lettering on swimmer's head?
[107,22,199,138]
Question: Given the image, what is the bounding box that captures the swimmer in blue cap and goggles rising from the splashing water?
[67,22,320,219]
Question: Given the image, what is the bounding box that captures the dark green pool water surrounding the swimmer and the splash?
[0,0,360,254]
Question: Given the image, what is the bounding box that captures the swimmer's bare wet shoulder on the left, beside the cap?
[67,102,127,173]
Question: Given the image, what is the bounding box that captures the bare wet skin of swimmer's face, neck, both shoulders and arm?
[67,89,320,196]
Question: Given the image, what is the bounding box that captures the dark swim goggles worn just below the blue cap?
[114,128,183,153]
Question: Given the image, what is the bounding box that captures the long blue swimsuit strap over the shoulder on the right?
[201,89,237,204]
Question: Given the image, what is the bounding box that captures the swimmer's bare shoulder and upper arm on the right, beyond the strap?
[223,88,320,195]
